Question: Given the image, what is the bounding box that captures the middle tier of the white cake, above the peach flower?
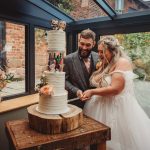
[44,71,65,95]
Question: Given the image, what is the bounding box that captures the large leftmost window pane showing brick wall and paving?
[0,21,25,96]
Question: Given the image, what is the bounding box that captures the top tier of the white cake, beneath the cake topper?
[47,30,66,52]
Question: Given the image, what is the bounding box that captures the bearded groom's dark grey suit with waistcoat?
[64,51,99,108]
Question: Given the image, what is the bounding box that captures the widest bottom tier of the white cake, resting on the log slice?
[36,91,69,114]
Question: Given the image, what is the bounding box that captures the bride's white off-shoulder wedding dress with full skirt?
[84,70,150,150]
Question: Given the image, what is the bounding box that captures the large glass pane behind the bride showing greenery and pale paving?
[100,32,150,117]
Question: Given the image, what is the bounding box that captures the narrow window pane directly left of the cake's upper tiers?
[35,28,48,86]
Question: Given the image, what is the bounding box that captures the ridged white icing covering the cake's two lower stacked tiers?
[36,71,69,114]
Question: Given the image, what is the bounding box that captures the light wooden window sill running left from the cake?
[0,94,39,114]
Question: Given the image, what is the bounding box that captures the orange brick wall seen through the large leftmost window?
[5,22,25,78]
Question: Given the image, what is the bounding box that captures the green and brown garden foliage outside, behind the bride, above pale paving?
[116,32,150,81]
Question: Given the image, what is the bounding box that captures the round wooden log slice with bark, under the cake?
[27,104,83,134]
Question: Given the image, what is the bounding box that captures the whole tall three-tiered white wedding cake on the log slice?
[36,20,69,114]
